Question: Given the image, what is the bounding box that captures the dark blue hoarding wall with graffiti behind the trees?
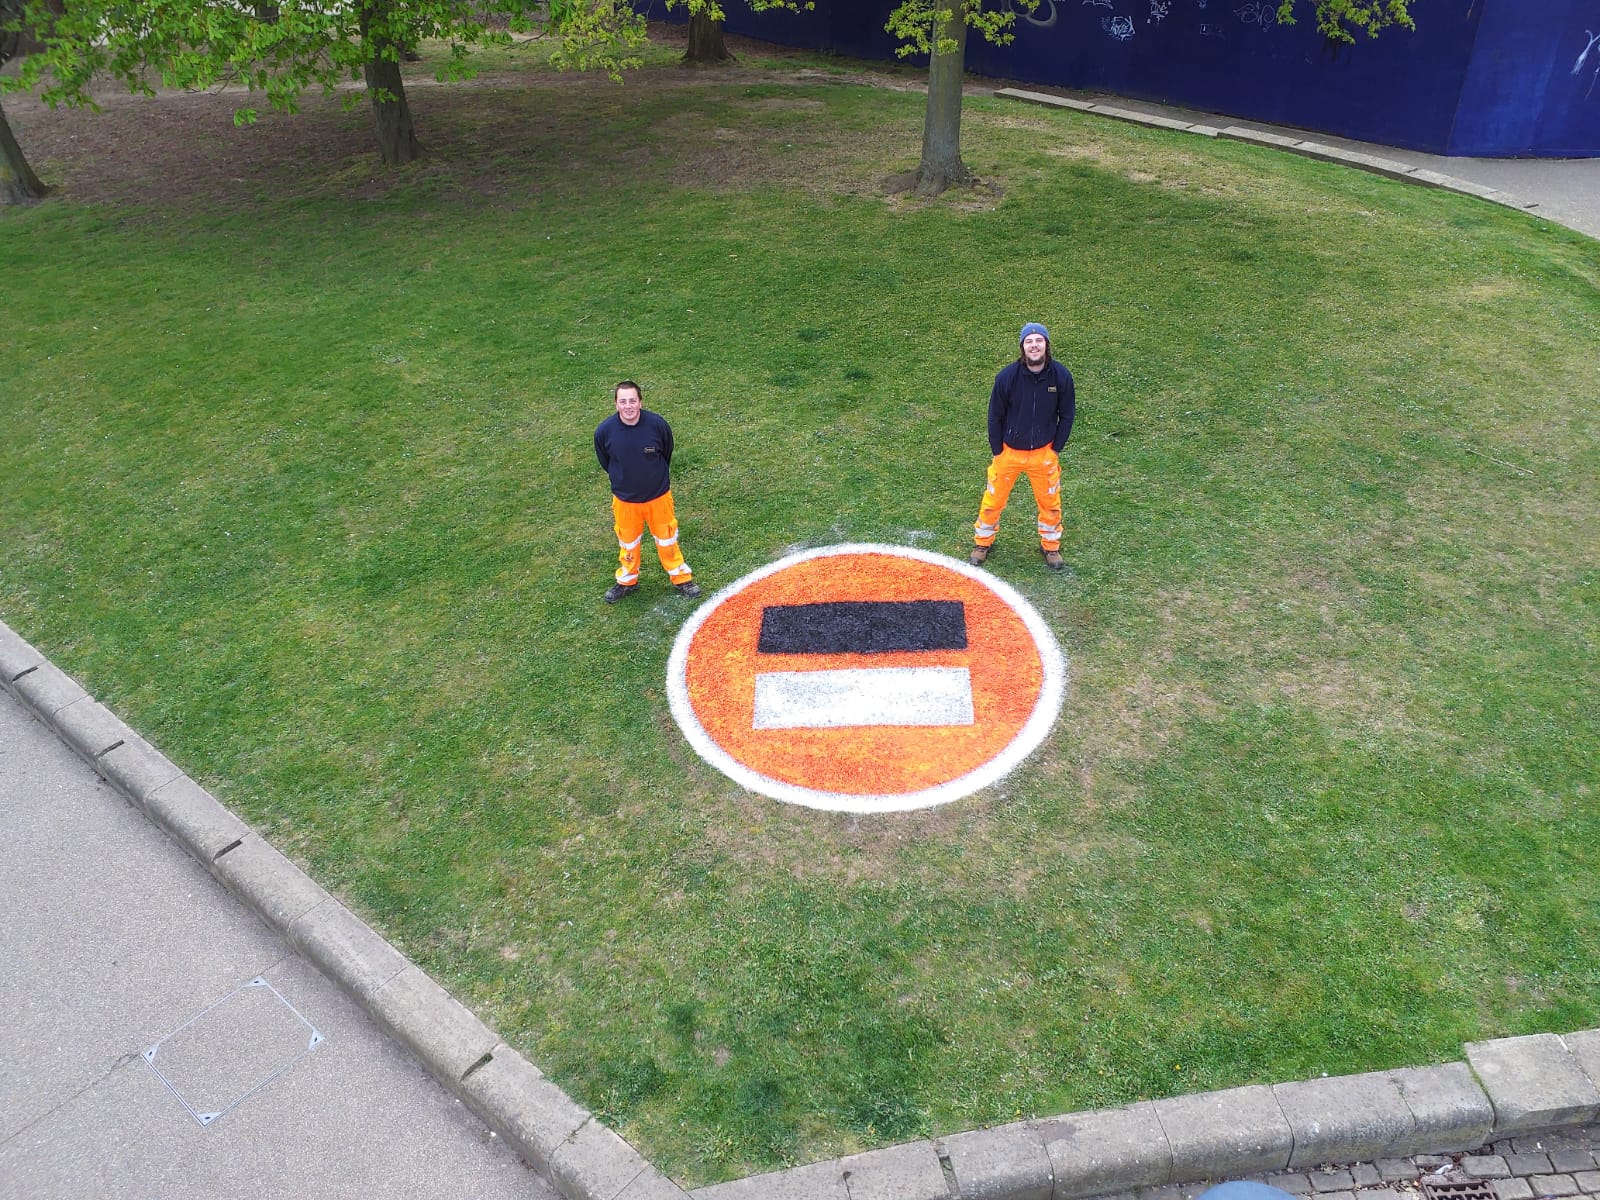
[691,0,1600,157]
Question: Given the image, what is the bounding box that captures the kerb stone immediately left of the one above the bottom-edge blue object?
[1034,1102,1173,1200]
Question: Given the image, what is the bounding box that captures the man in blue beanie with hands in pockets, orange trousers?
[968,322,1077,571]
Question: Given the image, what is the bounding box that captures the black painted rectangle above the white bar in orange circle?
[757,600,966,654]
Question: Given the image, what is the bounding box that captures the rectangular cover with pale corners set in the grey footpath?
[144,976,323,1125]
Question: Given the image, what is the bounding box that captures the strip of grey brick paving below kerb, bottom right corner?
[1126,1123,1600,1200]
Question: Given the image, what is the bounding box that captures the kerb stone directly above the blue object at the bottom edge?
[1155,1086,1294,1181]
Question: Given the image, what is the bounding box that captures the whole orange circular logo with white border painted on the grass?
[667,546,1066,813]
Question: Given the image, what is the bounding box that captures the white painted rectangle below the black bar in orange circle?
[754,667,973,730]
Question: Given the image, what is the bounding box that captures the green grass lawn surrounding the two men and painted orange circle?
[0,47,1600,1184]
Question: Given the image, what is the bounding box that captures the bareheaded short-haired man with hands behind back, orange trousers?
[595,379,699,605]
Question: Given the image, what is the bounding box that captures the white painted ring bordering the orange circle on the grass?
[667,542,1067,813]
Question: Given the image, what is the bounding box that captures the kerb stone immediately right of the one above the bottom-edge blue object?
[1272,1072,1414,1168]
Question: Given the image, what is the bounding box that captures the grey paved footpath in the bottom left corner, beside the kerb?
[0,690,557,1200]
